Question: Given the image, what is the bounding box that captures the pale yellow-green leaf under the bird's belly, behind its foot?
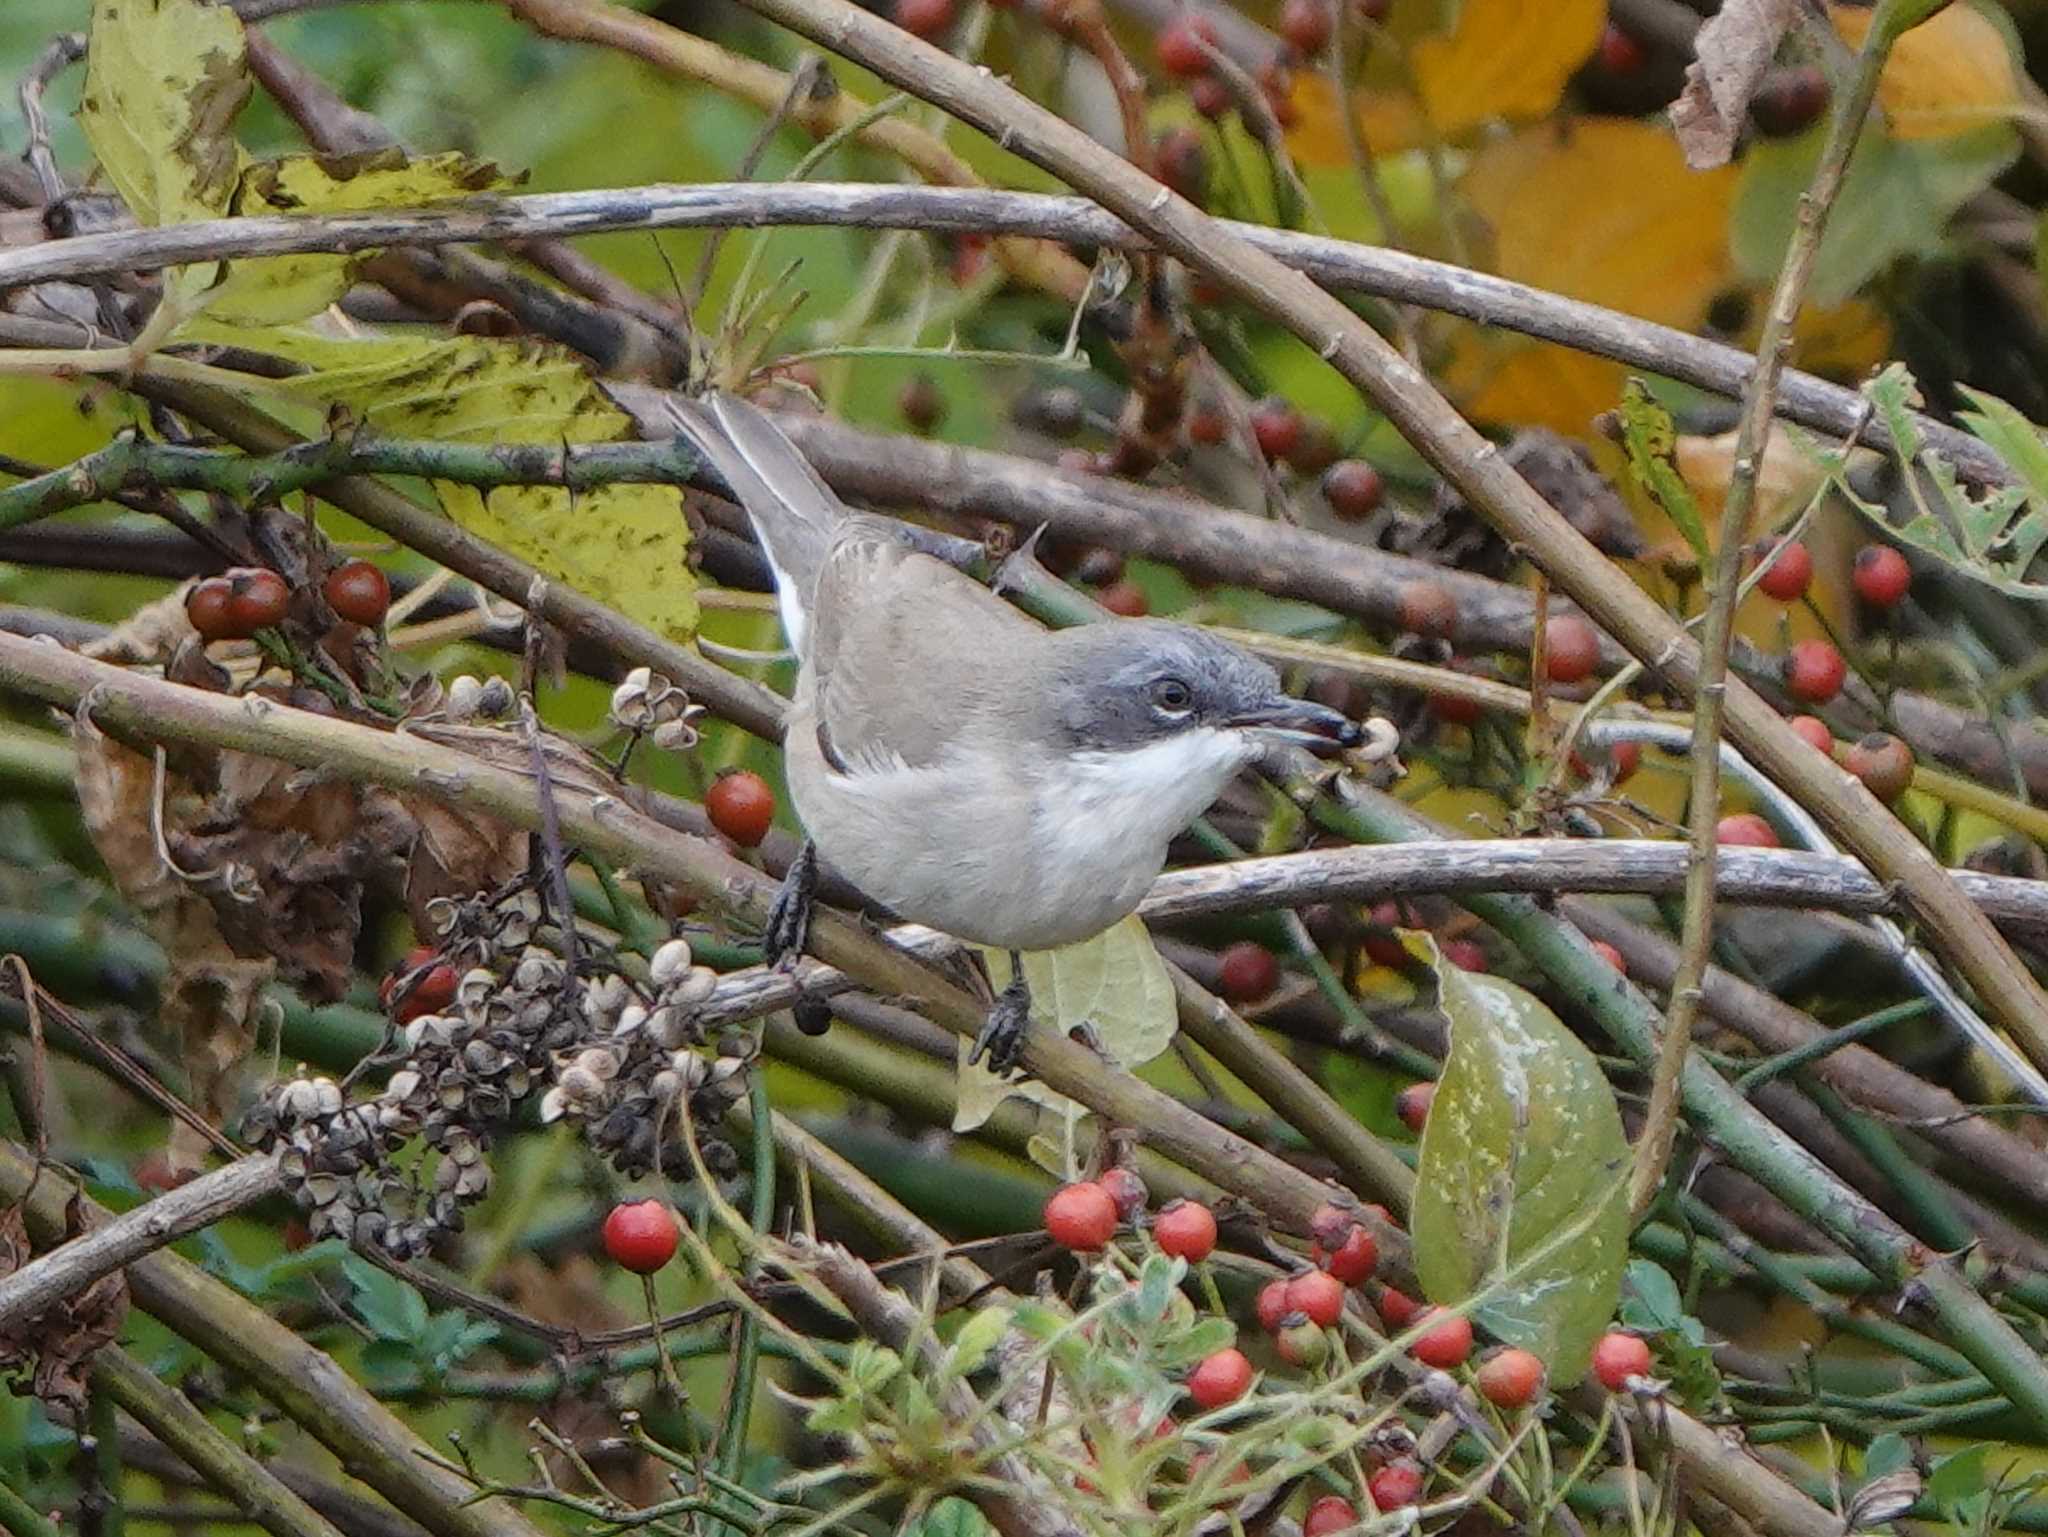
[952,916,1180,1131]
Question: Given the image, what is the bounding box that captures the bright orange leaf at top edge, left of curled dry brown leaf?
[1413,0,1608,133]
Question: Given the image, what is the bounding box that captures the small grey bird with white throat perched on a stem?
[670,391,1364,1074]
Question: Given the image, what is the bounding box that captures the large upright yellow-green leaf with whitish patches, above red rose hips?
[1407,937,1628,1381]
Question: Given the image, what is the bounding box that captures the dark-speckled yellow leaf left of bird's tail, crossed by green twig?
[217,326,696,637]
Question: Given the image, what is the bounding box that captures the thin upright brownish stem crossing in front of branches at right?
[1628,0,1898,1221]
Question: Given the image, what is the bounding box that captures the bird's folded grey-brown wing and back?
[809,518,1047,775]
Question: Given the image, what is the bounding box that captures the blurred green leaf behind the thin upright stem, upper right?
[1729,123,2019,305]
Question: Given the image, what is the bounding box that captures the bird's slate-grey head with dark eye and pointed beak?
[1047,619,1364,752]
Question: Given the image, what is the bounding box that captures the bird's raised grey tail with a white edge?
[668,391,848,652]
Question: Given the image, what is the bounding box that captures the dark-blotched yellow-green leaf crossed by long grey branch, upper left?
[205,148,506,326]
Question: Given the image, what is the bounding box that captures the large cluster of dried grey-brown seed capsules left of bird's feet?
[248,885,754,1260]
